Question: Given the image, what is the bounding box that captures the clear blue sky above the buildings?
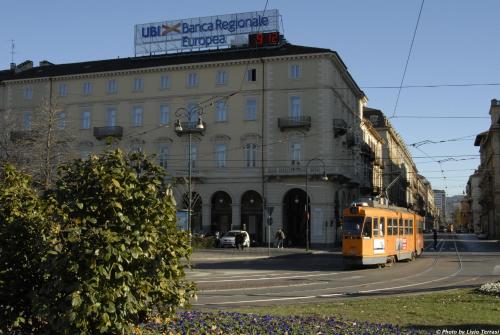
[0,0,500,195]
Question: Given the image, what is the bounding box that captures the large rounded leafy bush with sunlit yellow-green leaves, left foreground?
[38,150,194,334]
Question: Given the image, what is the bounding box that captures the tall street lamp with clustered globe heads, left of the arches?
[174,106,205,234]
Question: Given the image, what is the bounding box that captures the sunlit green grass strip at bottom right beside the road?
[234,289,500,330]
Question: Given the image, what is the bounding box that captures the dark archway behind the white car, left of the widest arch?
[240,191,263,243]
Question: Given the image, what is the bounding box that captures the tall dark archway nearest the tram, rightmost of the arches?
[283,188,311,247]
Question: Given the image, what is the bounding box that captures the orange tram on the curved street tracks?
[342,203,424,266]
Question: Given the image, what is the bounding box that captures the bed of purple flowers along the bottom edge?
[144,311,428,335]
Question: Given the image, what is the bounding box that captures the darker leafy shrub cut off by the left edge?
[0,166,50,333]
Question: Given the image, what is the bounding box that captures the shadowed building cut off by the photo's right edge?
[474,99,500,239]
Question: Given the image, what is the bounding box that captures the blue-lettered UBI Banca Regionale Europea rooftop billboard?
[134,9,279,55]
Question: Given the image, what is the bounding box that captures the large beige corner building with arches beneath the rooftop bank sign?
[0,44,372,246]
